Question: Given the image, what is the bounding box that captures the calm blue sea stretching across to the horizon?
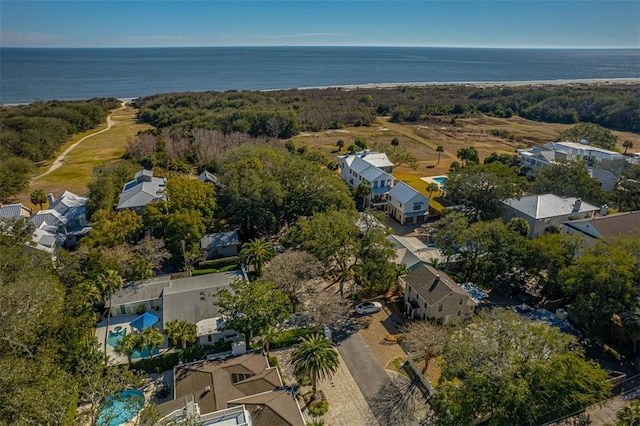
[0,47,640,104]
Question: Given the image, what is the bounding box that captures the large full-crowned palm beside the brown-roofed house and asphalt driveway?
[291,334,340,400]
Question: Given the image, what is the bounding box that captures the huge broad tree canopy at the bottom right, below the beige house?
[433,310,609,425]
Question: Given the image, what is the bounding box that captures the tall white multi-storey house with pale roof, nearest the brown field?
[338,150,394,207]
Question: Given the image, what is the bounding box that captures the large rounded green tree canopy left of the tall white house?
[219,147,355,236]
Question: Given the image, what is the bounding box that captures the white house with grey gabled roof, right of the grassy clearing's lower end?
[116,169,167,214]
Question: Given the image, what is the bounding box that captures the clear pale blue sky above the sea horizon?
[0,0,640,48]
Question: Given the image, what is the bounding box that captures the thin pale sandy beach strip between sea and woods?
[0,77,640,107]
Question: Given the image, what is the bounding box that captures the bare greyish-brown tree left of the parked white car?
[263,250,322,312]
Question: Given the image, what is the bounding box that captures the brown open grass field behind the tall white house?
[293,115,640,196]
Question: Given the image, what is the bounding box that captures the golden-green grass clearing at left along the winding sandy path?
[16,107,150,207]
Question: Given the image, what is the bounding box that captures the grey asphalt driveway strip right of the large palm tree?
[338,333,390,401]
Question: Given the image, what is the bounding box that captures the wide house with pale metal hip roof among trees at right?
[502,194,600,238]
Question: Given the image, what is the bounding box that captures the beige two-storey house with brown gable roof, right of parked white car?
[398,264,477,324]
